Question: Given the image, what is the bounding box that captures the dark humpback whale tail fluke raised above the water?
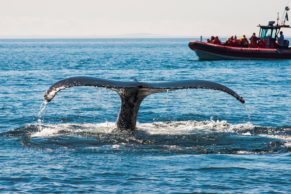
[44,77,245,130]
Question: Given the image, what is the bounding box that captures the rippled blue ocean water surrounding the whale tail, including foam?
[0,39,291,193]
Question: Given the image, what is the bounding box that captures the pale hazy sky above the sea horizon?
[0,0,291,37]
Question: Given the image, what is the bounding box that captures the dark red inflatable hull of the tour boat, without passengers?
[189,41,291,60]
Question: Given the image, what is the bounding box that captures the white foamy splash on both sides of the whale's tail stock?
[32,121,254,137]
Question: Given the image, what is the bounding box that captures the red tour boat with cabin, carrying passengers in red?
[189,7,291,60]
